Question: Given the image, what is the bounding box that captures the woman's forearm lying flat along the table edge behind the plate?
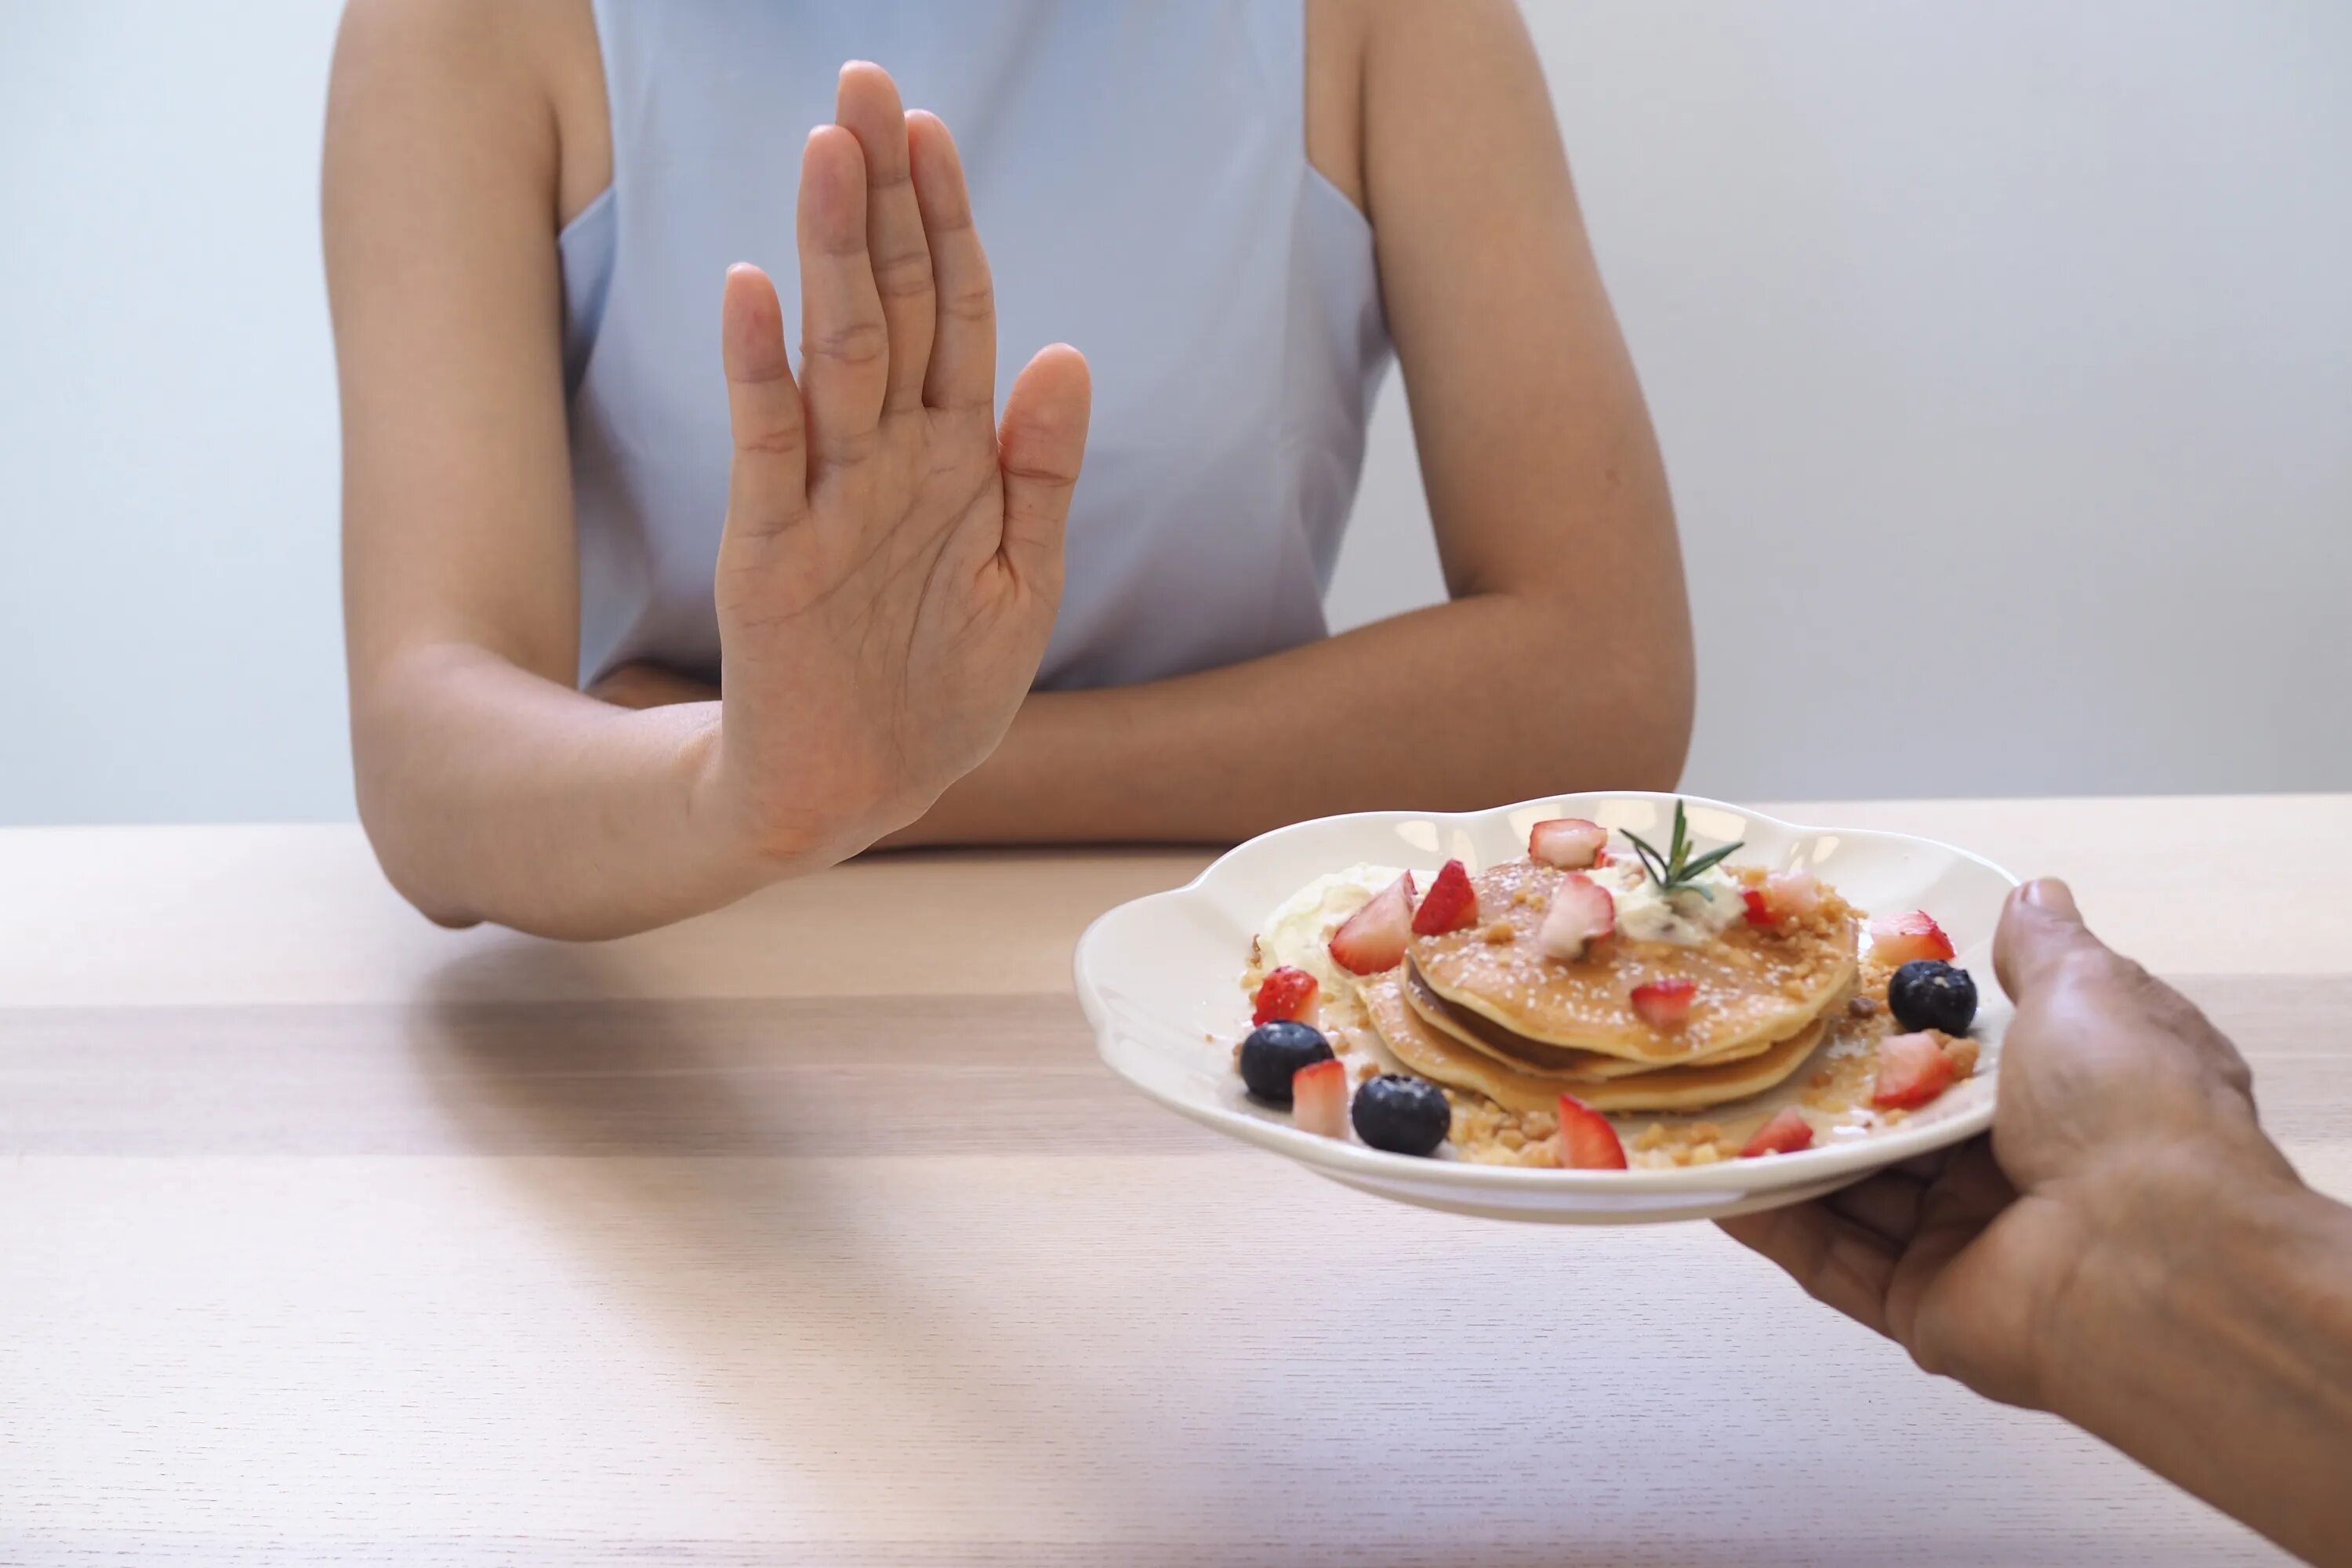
[889,593,1691,844]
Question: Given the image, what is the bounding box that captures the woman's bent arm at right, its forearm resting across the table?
[894,0,1693,841]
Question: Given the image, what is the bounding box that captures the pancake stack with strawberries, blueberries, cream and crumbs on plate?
[1235,801,1976,1168]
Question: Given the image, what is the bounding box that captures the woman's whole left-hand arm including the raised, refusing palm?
[325,0,1089,938]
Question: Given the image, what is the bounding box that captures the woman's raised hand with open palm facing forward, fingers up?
[708,64,1091,860]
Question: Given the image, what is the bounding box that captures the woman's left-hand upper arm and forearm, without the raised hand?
[322,2,755,933]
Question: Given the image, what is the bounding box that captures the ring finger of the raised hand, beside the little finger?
[800,125,889,473]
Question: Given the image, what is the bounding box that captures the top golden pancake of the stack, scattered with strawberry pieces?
[1406,860,1860,1067]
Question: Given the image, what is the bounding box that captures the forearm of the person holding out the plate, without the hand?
[2051,1171,2352,1563]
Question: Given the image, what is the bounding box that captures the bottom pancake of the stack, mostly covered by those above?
[1357,968,1830,1114]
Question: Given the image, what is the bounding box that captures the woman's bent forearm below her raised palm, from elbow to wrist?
[353,647,788,938]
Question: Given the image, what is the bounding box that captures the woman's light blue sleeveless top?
[560,0,1390,687]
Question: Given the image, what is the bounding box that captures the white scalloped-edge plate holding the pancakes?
[1075,792,2018,1225]
